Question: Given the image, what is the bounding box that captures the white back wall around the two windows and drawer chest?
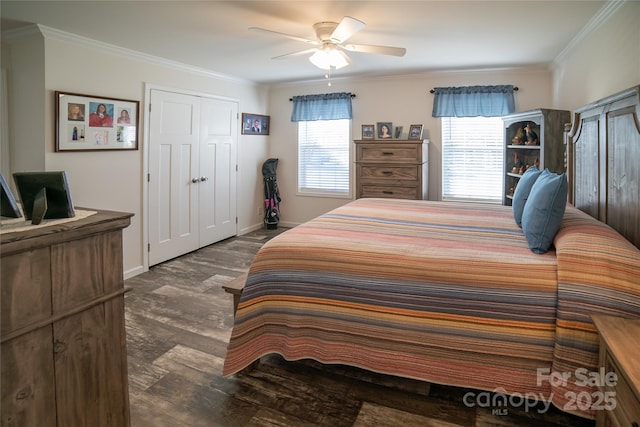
[269,68,552,225]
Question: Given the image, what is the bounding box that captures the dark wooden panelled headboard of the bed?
[567,86,640,248]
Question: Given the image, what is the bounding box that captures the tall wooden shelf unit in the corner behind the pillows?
[502,109,571,206]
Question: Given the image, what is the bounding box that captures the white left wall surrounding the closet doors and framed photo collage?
[3,28,269,277]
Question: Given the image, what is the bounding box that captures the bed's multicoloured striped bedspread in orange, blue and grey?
[223,88,640,418]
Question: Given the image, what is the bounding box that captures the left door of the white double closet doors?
[148,90,200,265]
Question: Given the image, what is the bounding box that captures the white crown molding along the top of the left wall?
[2,24,257,85]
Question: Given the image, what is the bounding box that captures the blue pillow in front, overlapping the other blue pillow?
[522,169,569,254]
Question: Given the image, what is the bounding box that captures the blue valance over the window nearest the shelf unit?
[432,85,515,117]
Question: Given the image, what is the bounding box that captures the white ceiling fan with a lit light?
[249,16,407,70]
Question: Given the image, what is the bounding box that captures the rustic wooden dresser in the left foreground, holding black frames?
[0,211,132,427]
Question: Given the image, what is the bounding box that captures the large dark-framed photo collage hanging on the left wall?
[55,91,140,151]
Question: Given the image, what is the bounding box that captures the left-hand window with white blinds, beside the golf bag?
[298,119,351,197]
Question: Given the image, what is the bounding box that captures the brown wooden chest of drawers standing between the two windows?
[354,139,429,200]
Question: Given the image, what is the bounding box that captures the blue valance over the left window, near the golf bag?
[291,92,352,122]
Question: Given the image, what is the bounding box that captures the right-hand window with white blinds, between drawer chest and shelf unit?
[442,117,504,203]
